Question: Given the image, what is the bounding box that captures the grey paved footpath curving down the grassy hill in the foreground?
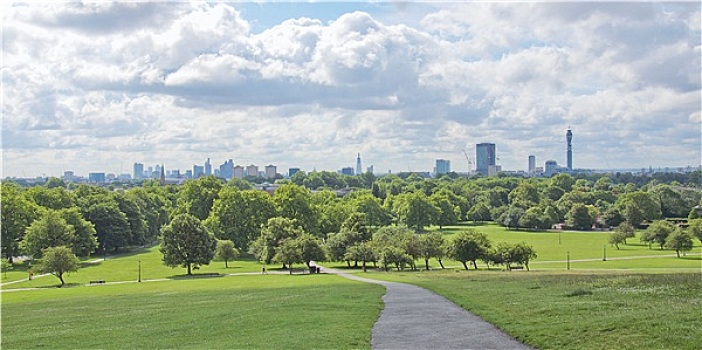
[323,268,530,349]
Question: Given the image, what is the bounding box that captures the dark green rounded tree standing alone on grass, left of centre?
[160,214,217,275]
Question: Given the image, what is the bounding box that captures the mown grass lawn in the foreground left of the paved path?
[2,275,384,349]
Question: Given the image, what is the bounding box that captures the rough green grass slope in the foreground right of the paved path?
[368,270,702,349]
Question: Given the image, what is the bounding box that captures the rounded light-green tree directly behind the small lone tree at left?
[21,210,75,258]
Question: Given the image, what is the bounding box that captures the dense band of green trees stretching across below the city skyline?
[2,172,702,261]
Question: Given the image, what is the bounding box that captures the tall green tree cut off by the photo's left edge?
[0,181,38,263]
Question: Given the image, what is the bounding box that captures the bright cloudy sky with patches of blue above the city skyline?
[1,1,702,177]
